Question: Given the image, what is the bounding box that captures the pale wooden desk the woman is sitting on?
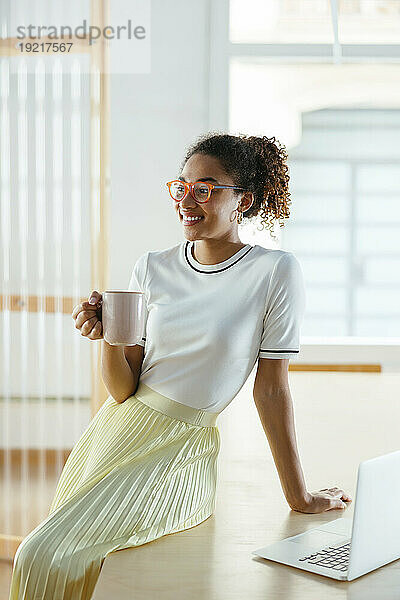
[93,372,400,600]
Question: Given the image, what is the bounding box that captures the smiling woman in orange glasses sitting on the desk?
[10,134,351,600]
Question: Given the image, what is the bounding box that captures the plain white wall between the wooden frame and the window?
[110,0,209,288]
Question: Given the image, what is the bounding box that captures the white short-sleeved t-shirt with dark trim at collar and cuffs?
[128,240,305,413]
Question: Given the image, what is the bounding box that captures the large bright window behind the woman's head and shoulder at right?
[210,0,400,340]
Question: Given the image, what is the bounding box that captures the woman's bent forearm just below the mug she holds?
[101,340,138,402]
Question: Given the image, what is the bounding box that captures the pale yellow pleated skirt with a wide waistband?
[9,382,220,600]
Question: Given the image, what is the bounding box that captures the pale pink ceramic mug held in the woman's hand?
[102,290,147,346]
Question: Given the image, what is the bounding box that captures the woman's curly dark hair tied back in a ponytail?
[181,132,291,238]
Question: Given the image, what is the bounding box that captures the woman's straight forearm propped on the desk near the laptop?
[254,389,309,510]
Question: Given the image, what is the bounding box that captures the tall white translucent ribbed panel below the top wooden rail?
[0,51,91,536]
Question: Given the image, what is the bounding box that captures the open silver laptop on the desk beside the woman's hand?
[252,450,400,581]
